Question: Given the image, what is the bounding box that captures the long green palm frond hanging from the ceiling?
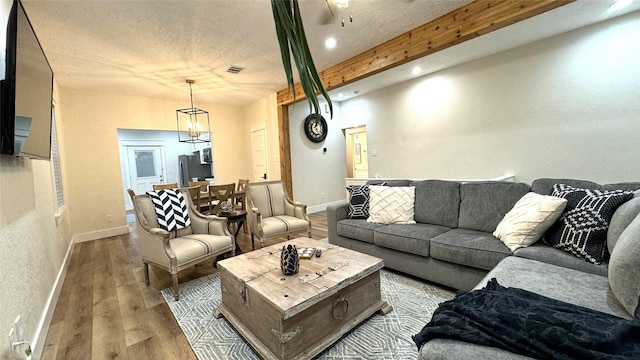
[271,0,333,117]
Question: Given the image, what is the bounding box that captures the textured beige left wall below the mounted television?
[0,81,72,359]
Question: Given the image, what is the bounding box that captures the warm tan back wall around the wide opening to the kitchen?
[61,88,246,240]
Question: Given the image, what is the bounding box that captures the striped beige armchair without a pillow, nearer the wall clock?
[246,181,311,249]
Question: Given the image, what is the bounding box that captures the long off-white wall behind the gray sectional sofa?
[340,12,640,183]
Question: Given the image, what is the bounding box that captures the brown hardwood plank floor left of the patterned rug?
[40,212,327,360]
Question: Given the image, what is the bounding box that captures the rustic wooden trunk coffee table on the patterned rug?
[215,238,391,360]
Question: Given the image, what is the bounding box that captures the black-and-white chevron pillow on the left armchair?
[147,189,191,231]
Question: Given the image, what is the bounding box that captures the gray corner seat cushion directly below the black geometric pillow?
[513,242,608,276]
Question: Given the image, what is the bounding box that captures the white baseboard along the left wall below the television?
[31,240,75,359]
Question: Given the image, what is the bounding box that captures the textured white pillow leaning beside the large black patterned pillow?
[493,192,567,251]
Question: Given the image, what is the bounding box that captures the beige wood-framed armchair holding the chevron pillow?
[127,189,235,300]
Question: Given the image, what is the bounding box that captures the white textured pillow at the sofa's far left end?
[367,186,416,224]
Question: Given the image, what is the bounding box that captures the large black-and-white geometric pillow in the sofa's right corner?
[543,184,633,264]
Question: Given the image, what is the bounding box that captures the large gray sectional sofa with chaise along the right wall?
[327,178,640,359]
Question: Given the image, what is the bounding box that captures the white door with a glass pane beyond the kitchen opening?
[127,145,164,194]
